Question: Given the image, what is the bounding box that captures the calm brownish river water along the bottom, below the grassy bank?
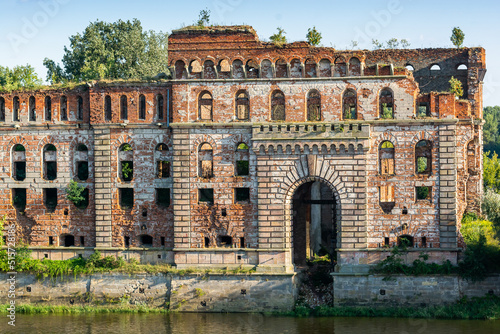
[0,313,500,334]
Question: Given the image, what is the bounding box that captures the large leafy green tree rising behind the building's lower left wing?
[44,19,168,83]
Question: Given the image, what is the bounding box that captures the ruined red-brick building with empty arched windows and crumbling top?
[0,26,486,272]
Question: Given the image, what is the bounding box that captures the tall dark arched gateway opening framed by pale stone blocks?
[292,180,338,266]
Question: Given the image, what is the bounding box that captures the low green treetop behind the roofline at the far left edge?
[0,65,43,91]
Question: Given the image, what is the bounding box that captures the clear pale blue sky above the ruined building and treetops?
[0,0,500,106]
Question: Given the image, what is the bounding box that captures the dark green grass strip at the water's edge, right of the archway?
[282,296,500,320]
